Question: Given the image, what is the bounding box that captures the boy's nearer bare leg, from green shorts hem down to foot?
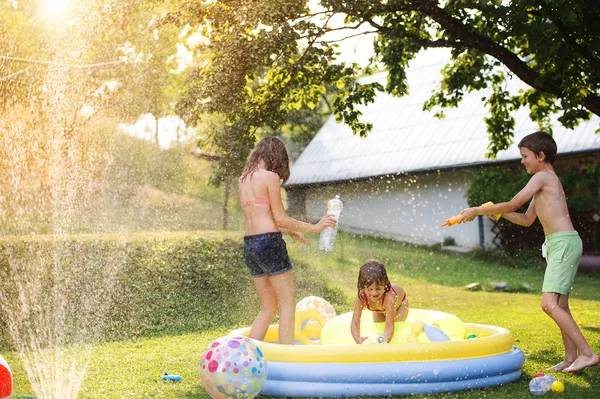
[542,292,600,373]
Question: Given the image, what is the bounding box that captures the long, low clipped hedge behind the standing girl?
[0,232,343,345]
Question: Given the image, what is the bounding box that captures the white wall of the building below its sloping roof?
[306,170,493,248]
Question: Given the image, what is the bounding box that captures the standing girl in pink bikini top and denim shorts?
[238,137,336,344]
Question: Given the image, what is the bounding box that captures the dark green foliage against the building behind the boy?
[467,160,600,213]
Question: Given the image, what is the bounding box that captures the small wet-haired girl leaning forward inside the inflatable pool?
[350,260,408,344]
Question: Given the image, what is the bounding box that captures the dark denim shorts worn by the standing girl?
[244,232,292,277]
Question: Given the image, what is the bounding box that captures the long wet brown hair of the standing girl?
[241,136,290,182]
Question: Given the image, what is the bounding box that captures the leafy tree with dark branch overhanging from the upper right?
[174,0,600,158]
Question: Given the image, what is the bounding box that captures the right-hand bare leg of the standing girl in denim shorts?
[269,270,296,345]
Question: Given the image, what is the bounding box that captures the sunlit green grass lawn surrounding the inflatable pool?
[3,234,600,399]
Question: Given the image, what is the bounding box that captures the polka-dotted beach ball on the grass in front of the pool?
[198,336,267,399]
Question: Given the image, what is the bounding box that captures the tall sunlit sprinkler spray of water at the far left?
[0,1,141,399]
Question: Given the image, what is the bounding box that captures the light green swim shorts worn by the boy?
[542,231,583,295]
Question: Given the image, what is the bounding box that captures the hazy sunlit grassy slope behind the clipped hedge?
[0,121,241,235]
